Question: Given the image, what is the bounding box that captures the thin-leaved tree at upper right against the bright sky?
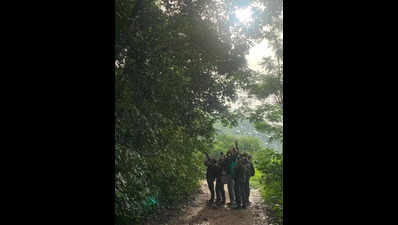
[239,0,283,141]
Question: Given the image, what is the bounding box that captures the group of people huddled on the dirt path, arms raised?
[205,141,254,209]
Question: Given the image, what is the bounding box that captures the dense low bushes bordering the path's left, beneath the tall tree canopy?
[116,139,203,224]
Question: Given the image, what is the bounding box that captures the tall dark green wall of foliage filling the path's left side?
[115,0,258,225]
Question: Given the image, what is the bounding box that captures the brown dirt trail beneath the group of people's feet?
[146,180,269,225]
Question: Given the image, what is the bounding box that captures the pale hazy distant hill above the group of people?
[214,120,282,152]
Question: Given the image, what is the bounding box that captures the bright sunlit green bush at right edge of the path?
[255,148,283,224]
